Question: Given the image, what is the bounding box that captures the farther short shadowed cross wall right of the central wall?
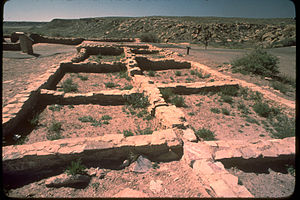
[136,57,191,70]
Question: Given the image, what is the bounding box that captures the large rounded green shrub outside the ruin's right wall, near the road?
[232,49,279,76]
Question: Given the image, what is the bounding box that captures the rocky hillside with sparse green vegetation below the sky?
[3,16,296,48]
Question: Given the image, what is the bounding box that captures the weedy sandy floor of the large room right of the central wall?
[182,94,271,141]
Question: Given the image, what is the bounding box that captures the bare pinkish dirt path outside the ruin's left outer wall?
[2,44,76,107]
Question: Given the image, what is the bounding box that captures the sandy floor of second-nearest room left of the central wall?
[57,73,131,93]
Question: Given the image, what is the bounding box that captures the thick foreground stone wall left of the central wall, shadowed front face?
[2,129,182,187]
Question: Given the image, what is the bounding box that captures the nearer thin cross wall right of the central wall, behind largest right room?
[156,81,239,94]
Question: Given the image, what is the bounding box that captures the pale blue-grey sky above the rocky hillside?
[3,0,296,21]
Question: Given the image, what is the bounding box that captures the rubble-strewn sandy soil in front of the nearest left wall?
[8,161,209,198]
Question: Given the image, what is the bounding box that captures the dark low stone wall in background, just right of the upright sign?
[29,33,84,45]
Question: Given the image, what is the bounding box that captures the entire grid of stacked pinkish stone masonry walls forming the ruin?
[2,38,295,197]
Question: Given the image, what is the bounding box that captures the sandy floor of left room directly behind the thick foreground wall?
[25,104,159,144]
